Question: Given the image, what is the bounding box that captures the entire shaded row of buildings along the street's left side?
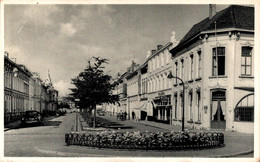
[4,52,58,123]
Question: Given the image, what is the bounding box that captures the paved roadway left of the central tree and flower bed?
[4,114,75,157]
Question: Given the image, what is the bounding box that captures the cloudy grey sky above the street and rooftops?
[4,5,228,96]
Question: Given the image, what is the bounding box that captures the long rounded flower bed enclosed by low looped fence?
[65,131,224,150]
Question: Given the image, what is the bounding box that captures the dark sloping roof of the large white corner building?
[175,5,254,52]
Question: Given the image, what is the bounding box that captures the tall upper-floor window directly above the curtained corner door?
[212,47,225,76]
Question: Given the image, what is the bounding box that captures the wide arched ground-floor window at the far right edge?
[235,94,254,122]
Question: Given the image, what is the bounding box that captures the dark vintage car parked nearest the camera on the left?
[21,110,42,125]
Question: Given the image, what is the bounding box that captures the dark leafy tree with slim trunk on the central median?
[70,57,119,128]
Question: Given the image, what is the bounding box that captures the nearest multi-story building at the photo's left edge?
[4,53,32,122]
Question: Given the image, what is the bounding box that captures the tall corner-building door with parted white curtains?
[211,91,226,129]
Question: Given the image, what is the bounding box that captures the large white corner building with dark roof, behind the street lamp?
[170,5,254,133]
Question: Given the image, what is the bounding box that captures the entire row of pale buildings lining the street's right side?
[103,5,254,133]
